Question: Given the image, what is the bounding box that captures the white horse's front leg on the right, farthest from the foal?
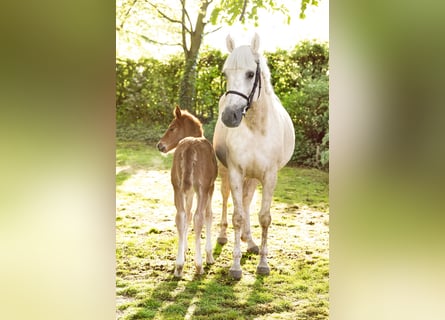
[256,170,277,275]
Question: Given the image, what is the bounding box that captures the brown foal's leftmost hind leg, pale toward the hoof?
[175,188,188,278]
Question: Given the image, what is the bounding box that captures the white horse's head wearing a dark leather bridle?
[220,34,263,128]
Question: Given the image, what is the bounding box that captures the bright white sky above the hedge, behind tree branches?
[116,0,329,60]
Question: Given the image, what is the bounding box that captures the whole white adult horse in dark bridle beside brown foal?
[213,34,295,279]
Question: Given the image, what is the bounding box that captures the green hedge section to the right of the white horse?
[266,41,329,169]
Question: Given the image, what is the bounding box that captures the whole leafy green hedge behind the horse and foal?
[116,41,329,169]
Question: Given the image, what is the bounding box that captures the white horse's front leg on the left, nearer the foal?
[229,169,244,280]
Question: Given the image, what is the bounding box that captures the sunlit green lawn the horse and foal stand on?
[116,143,329,319]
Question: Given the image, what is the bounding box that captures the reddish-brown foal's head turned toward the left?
[157,106,203,152]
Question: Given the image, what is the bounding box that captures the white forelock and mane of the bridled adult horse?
[223,45,273,94]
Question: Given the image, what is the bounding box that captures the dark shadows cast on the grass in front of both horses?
[130,244,294,320]
